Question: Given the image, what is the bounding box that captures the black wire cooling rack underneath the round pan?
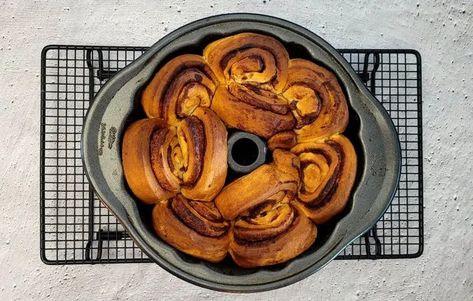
[40,45,423,264]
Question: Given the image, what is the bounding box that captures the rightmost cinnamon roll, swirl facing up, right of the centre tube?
[291,135,357,224]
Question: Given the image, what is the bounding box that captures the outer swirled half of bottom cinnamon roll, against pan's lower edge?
[229,202,317,268]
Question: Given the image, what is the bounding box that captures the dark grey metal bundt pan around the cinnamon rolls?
[82,14,400,292]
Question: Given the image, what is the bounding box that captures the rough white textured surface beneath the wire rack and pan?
[0,0,473,300]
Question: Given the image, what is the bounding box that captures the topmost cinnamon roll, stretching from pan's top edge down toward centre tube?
[204,33,295,138]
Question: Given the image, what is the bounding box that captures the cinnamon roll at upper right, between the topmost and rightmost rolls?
[282,59,348,142]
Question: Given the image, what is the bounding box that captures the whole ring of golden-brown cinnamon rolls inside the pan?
[122,33,357,267]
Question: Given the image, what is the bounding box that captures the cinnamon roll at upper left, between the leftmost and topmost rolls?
[141,54,217,125]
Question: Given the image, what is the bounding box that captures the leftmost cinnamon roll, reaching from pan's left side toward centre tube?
[144,108,227,201]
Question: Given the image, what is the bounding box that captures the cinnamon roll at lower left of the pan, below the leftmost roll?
[153,194,230,262]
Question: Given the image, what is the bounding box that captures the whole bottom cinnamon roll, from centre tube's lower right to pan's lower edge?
[215,150,317,267]
